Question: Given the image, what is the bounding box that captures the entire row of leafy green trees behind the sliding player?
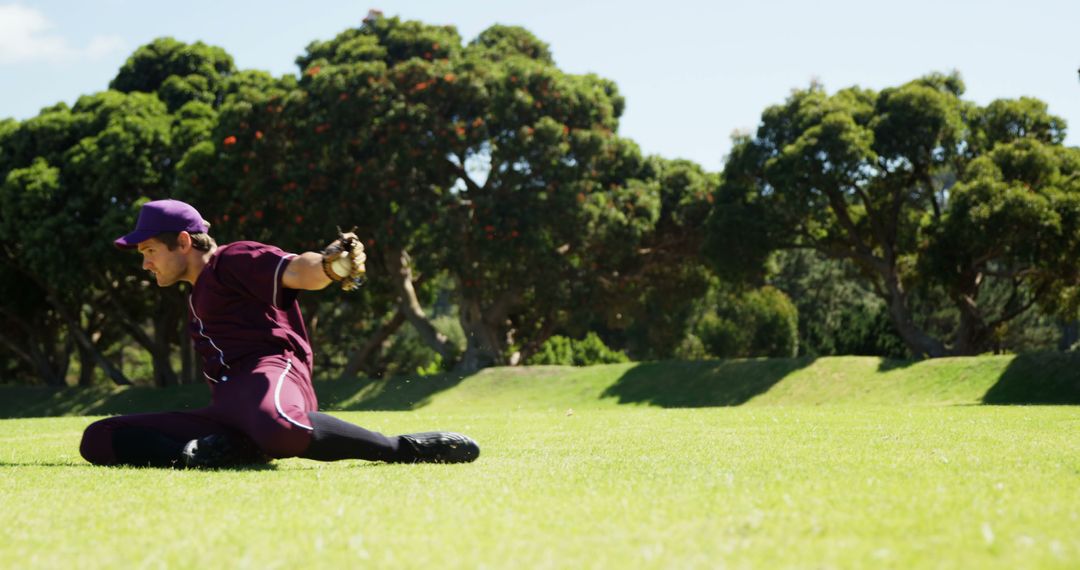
[0,16,1080,386]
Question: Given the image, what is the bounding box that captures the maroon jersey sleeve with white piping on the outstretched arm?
[217,242,298,309]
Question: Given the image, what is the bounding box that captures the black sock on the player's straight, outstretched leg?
[300,411,411,462]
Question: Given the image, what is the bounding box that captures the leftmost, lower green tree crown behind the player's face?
[0,91,178,383]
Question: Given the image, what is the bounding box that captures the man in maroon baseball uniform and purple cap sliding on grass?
[80,200,480,467]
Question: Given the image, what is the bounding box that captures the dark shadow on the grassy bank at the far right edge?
[983,352,1080,405]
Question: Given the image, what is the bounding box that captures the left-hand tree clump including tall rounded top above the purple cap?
[0,39,232,385]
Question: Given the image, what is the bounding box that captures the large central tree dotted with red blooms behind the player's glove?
[251,17,651,370]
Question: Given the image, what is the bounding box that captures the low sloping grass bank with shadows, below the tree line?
[0,353,1080,418]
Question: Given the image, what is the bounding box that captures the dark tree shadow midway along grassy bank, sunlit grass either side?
[602,357,814,408]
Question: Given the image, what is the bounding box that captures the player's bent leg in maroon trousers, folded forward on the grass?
[79,410,261,467]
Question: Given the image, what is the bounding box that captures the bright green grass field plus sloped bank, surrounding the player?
[0,355,1080,569]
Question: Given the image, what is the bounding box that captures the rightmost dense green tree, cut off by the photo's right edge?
[921,135,1080,354]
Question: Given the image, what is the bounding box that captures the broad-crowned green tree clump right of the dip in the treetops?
[710,74,1080,356]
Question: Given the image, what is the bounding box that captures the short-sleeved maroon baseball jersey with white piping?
[188,242,312,382]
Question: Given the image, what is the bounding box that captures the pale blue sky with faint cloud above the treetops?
[0,0,1080,171]
